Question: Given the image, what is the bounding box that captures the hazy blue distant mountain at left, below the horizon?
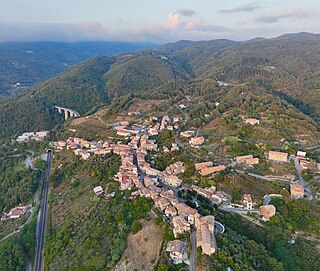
[0,42,155,97]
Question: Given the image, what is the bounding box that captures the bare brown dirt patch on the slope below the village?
[113,221,162,271]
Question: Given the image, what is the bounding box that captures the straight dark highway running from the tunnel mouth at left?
[33,150,52,271]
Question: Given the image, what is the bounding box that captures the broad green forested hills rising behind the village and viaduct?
[0,33,320,140]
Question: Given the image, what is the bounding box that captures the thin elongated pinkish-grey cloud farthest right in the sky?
[255,8,309,23]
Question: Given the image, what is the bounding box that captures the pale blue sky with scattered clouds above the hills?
[0,0,320,44]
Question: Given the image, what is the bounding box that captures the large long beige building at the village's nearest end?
[195,215,216,256]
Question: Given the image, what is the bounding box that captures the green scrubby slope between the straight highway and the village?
[45,153,151,270]
